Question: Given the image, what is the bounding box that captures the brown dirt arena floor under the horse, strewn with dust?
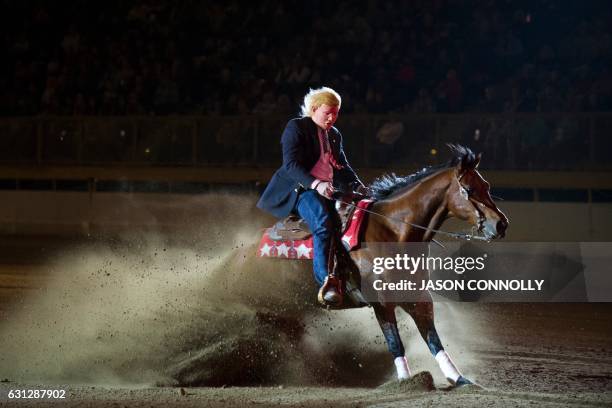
[0,231,612,407]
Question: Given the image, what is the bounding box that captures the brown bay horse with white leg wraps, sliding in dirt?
[350,145,508,386]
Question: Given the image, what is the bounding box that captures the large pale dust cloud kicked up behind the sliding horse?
[0,194,488,386]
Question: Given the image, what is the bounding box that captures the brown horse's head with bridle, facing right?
[447,145,508,239]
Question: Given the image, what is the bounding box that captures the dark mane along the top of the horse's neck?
[370,143,477,200]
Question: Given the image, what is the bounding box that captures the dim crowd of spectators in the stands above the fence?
[0,0,612,116]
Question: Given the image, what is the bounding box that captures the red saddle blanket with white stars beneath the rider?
[257,200,374,259]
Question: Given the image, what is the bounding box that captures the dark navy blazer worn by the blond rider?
[257,117,361,218]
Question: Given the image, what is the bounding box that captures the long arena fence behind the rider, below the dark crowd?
[0,113,612,171]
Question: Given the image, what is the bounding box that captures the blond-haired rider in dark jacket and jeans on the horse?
[257,87,366,305]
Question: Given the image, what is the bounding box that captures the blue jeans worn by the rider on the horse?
[295,190,333,286]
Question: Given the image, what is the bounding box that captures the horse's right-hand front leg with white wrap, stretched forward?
[399,302,472,386]
